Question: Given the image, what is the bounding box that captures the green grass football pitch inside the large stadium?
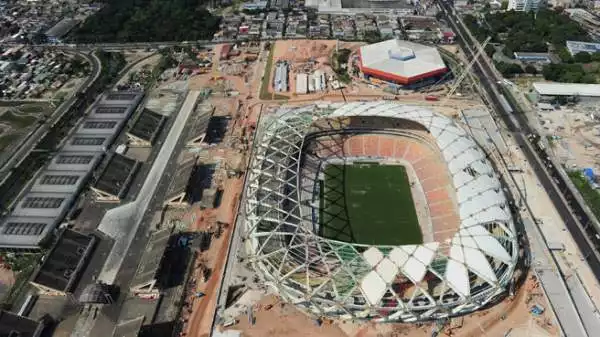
[319,163,423,245]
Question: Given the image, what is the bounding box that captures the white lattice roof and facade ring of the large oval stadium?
[242,102,519,321]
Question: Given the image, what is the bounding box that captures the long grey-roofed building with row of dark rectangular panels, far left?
[0,91,143,251]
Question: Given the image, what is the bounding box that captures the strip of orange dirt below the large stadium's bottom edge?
[221,277,559,337]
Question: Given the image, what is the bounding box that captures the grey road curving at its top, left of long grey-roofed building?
[0,50,102,178]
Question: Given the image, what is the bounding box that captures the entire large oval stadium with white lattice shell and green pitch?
[242,102,519,322]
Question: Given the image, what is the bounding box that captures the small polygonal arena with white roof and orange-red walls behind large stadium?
[359,39,448,84]
